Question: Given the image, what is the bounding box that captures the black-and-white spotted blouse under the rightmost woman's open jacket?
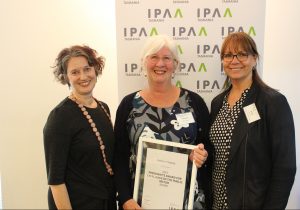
[210,89,249,209]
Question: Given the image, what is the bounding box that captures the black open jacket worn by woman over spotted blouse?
[211,82,296,209]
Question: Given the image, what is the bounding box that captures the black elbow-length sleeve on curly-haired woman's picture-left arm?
[43,107,71,185]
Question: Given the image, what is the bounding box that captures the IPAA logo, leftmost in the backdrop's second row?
[123,27,158,41]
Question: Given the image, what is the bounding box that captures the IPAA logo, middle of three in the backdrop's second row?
[172,26,207,40]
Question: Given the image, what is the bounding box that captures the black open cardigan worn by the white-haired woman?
[113,89,210,206]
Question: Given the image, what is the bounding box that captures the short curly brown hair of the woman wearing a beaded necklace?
[52,45,105,86]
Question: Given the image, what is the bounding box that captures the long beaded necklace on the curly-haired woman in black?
[69,93,114,176]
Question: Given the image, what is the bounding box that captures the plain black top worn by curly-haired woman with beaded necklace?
[44,98,115,208]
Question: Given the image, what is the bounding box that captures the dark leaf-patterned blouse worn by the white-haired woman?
[126,89,204,206]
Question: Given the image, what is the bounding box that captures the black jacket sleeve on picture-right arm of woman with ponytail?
[263,94,296,209]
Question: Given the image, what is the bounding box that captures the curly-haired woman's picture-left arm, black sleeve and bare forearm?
[43,106,74,209]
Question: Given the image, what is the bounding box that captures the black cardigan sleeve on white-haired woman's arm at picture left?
[113,93,133,206]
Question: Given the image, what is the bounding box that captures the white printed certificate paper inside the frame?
[142,148,188,209]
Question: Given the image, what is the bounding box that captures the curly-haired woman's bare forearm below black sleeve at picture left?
[50,184,72,209]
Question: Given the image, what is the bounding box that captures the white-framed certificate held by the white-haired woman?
[133,137,197,209]
